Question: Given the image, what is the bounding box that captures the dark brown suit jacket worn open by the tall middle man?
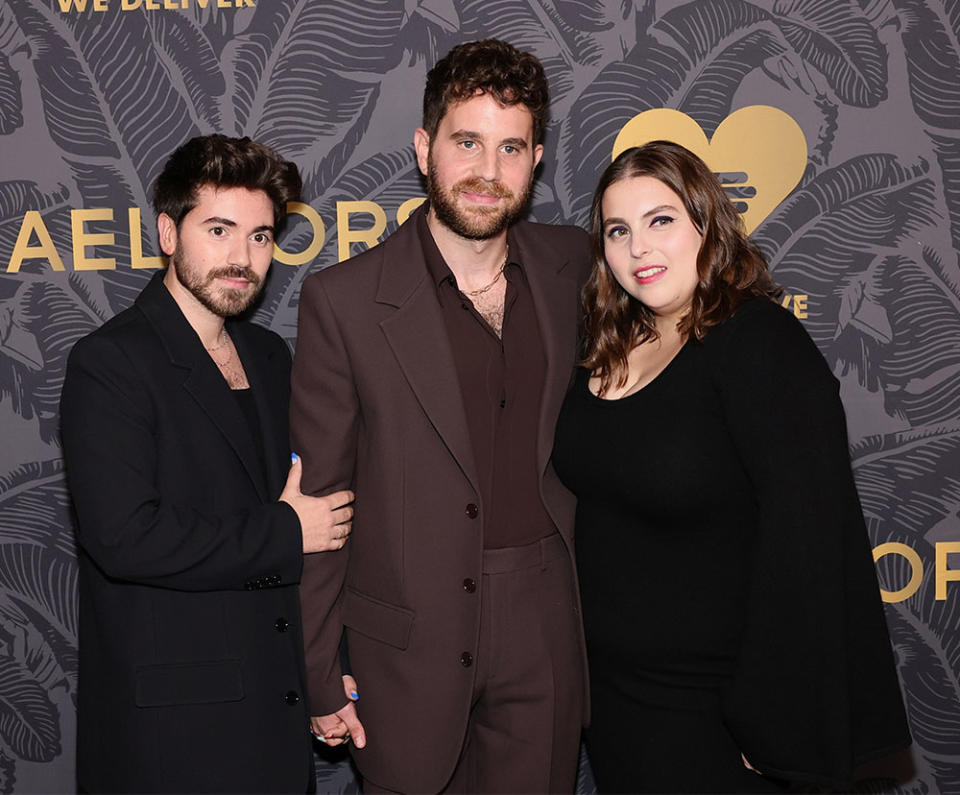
[291,208,589,792]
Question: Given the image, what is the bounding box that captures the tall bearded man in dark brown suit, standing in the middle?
[291,40,589,793]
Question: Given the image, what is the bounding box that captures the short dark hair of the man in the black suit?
[153,134,303,229]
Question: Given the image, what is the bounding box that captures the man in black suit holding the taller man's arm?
[60,135,353,792]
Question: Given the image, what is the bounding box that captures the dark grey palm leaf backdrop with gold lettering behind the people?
[0,0,960,793]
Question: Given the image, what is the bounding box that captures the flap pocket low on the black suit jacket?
[135,660,243,707]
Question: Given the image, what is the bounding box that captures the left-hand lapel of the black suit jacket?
[137,272,268,502]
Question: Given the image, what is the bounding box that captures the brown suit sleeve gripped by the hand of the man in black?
[290,276,360,715]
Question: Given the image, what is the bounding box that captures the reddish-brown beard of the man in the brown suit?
[427,155,533,240]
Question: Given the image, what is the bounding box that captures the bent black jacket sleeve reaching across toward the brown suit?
[60,335,303,591]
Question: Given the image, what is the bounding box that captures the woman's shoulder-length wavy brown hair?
[581,141,783,395]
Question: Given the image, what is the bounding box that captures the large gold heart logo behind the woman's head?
[613,105,807,234]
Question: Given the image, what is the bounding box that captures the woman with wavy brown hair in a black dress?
[554,141,910,792]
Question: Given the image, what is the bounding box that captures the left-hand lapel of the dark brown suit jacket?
[377,218,479,488]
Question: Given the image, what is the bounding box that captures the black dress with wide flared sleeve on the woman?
[554,300,909,792]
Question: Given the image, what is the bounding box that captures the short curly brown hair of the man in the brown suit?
[423,39,550,144]
